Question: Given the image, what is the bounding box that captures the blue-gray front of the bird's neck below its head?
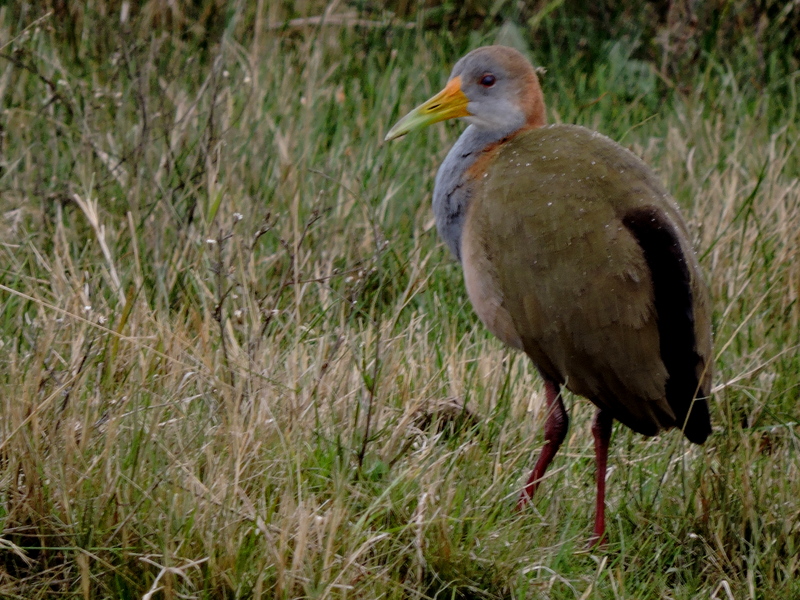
[433,125,513,262]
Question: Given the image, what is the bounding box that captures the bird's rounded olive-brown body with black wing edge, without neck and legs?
[461,125,711,443]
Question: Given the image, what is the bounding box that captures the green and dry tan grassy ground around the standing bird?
[0,3,800,600]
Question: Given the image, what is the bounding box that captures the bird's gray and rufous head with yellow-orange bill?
[386,46,546,140]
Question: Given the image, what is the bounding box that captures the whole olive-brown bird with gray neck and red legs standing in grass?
[385,46,713,547]
